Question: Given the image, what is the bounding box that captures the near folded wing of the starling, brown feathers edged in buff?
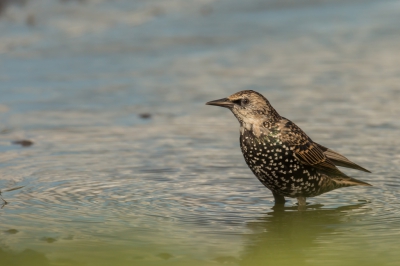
[280,119,346,176]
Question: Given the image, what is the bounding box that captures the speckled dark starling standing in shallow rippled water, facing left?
[206,90,371,206]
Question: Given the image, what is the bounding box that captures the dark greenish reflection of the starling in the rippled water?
[240,204,364,266]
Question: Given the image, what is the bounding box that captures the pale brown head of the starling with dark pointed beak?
[206,90,280,128]
